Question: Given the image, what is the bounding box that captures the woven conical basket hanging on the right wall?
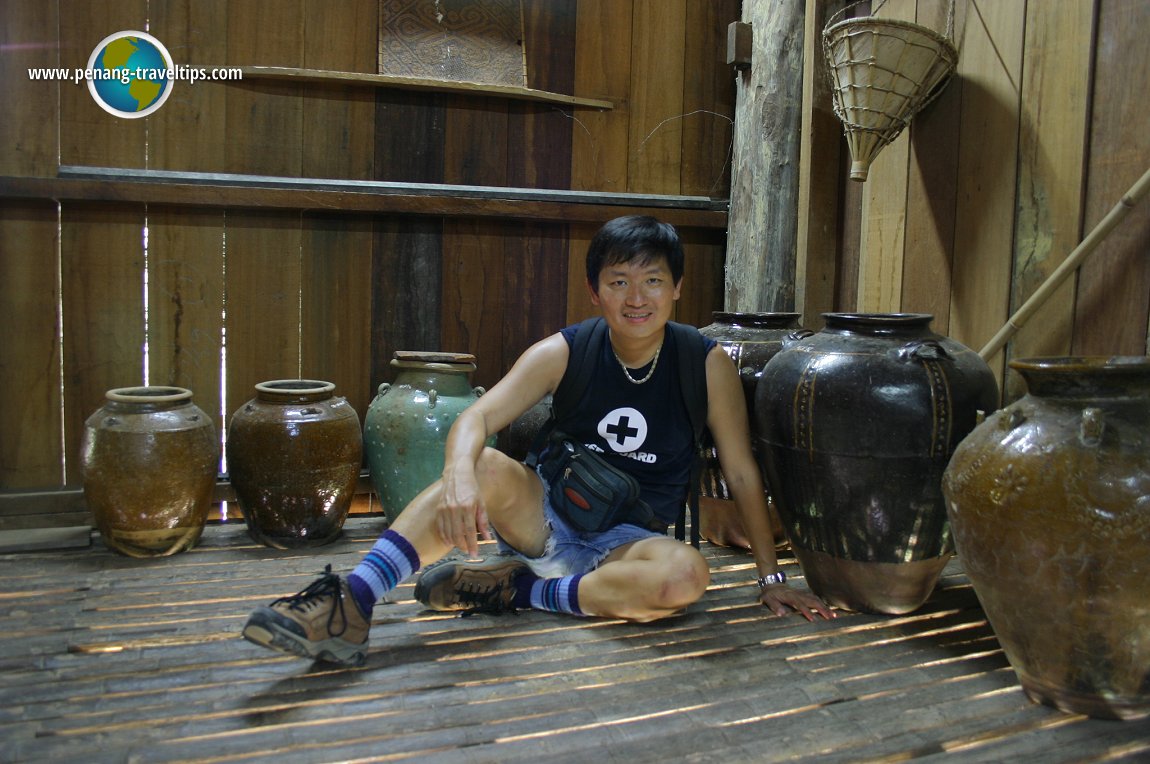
[822,10,958,181]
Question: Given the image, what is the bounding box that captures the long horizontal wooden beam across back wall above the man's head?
[0,166,728,230]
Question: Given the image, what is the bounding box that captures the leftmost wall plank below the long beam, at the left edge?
[0,201,64,489]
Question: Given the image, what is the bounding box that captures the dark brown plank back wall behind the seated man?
[0,0,739,527]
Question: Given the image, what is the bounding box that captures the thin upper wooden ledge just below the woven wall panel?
[216,67,614,109]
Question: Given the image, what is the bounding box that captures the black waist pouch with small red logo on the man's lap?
[539,433,654,533]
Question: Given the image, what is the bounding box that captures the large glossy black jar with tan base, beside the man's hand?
[754,313,998,613]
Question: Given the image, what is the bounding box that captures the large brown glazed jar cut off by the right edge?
[943,356,1150,718]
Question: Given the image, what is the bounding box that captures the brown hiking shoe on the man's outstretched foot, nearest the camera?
[244,565,371,666]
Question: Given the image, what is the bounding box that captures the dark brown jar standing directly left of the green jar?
[227,380,363,549]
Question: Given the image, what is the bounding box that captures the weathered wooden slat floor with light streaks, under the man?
[0,518,1150,763]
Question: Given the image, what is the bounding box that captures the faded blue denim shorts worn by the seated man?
[496,464,666,579]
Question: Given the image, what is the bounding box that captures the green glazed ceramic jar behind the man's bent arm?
[363,350,496,522]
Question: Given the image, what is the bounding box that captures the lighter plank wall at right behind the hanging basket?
[799,0,1150,399]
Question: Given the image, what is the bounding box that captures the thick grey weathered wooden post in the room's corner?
[725,0,805,311]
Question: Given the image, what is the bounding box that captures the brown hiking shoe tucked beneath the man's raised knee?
[415,556,529,614]
